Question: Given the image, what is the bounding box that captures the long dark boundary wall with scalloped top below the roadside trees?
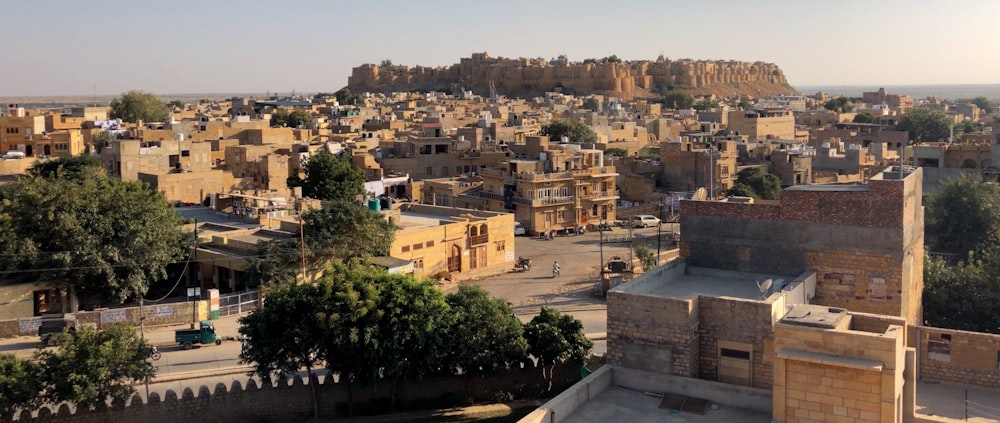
[0,366,580,423]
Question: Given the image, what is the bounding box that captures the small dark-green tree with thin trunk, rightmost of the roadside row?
[524,307,594,390]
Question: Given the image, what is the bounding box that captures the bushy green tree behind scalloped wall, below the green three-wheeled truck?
[35,323,156,410]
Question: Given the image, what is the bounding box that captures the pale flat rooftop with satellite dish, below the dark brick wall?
[626,266,791,300]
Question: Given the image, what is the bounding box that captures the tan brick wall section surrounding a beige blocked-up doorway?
[698,296,774,389]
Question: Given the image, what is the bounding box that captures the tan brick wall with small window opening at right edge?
[910,326,1000,388]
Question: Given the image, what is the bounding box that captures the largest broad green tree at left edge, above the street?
[0,176,191,303]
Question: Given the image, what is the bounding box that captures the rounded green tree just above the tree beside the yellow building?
[287,149,365,201]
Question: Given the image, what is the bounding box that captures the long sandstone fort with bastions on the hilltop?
[348,53,795,99]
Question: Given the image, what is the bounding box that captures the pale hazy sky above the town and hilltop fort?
[0,0,1000,97]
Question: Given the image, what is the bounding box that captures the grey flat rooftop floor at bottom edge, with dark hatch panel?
[558,385,771,423]
